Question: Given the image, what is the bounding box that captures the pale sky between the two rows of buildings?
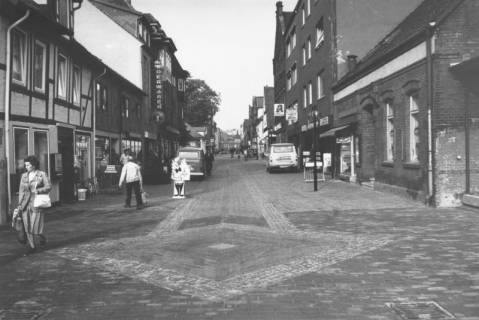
[132,0,297,129]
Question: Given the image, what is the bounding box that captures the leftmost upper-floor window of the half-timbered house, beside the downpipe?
[12,30,27,85]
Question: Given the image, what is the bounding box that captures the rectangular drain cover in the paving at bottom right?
[386,301,456,320]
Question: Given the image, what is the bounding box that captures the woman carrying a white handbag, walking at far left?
[18,156,52,252]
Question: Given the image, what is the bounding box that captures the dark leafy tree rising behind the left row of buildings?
[184,79,221,126]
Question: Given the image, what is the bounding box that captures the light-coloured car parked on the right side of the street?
[266,143,298,172]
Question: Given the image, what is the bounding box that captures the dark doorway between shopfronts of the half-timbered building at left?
[58,127,75,203]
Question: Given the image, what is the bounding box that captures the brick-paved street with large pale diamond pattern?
[0,159,479,320]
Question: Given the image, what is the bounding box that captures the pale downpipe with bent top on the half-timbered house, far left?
[4,9,30,212]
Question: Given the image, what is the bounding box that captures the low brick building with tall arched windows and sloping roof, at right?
[333,0,479,206]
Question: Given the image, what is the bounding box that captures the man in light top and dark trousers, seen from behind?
[118,156,143,209]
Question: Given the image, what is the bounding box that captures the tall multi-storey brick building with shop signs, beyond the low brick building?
[273,0,420,172]
